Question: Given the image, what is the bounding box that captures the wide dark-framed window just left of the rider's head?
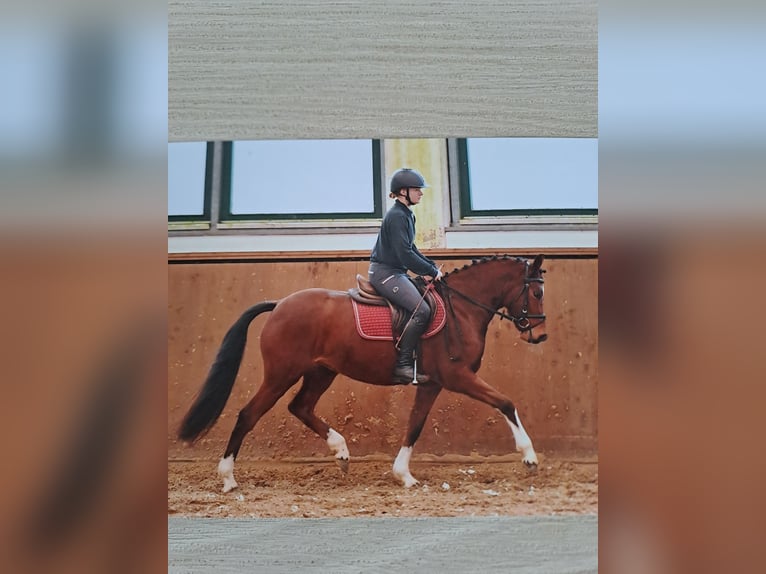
[221,140,382,221]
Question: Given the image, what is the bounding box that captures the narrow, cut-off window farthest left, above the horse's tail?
[168,142,213,221]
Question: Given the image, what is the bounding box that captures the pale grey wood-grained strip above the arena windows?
[168,0,598,141]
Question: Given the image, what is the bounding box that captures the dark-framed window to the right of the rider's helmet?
[457,138,598,218]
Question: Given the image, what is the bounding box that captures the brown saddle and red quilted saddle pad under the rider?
[348,274,447,340]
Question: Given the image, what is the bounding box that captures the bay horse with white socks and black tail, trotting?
[178,255,547,492]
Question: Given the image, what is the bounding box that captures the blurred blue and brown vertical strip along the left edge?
[0,0,167,572]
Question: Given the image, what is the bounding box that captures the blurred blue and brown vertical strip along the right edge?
[599,0,766,572]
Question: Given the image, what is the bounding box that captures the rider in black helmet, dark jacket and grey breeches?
[369,168,442,383]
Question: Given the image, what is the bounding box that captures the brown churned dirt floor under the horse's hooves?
[168,455,598,518]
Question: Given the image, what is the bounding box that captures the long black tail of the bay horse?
[178,301,277,442]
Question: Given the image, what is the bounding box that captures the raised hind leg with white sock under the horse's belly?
[287,367,350,472]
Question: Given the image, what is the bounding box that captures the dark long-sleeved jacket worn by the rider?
[370,201,439,277]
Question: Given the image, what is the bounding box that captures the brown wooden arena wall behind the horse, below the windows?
[168,254,598,460]
